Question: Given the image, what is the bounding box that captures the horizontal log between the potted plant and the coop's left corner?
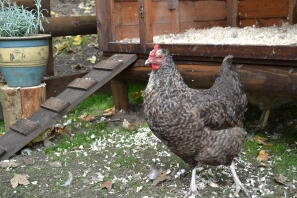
[43,16,96,38]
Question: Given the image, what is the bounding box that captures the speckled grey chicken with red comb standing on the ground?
[144,45,248,194]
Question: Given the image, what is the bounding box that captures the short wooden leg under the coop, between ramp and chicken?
[111,77,128,111]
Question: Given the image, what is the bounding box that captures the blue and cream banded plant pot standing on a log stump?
[0,34,51,87]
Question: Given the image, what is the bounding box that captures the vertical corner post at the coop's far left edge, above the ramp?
[96,0,112,51]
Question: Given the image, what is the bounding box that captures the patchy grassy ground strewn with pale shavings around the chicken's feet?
[0,86,297,198]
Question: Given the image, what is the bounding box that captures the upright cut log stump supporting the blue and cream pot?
[0,84,46,130]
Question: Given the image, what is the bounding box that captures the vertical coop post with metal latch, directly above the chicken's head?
[138,0,153,50]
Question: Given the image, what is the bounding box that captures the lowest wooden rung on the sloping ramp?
[10,118,39,136]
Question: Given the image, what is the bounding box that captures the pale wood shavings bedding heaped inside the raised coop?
[119,23,297,46]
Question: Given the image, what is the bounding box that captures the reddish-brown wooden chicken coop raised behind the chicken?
[97,0,297,108]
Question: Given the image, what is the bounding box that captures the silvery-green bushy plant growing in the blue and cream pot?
[0,0,44,37]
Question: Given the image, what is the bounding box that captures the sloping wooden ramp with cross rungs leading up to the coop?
[0,54,137,160]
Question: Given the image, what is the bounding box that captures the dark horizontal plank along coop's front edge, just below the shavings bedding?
[109,42,297,64]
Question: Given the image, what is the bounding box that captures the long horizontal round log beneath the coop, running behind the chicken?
[119,60,297,97]
